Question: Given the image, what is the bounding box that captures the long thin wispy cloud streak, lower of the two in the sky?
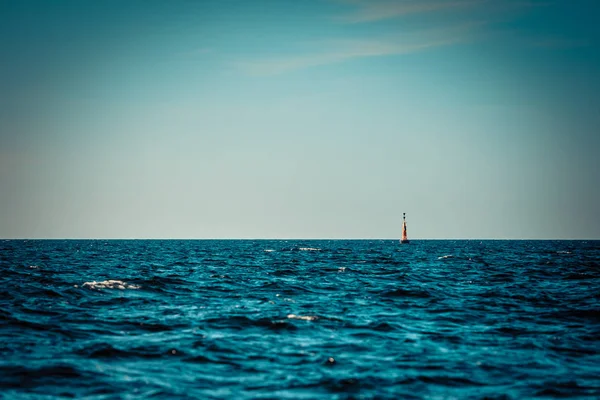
[238,23,483,75]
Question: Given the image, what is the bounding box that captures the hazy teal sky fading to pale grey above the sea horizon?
[0,0,600,239]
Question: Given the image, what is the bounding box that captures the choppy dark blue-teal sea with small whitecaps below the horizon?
[0,240,600,399]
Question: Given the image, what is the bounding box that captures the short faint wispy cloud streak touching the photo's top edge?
[336,0,489,23]
